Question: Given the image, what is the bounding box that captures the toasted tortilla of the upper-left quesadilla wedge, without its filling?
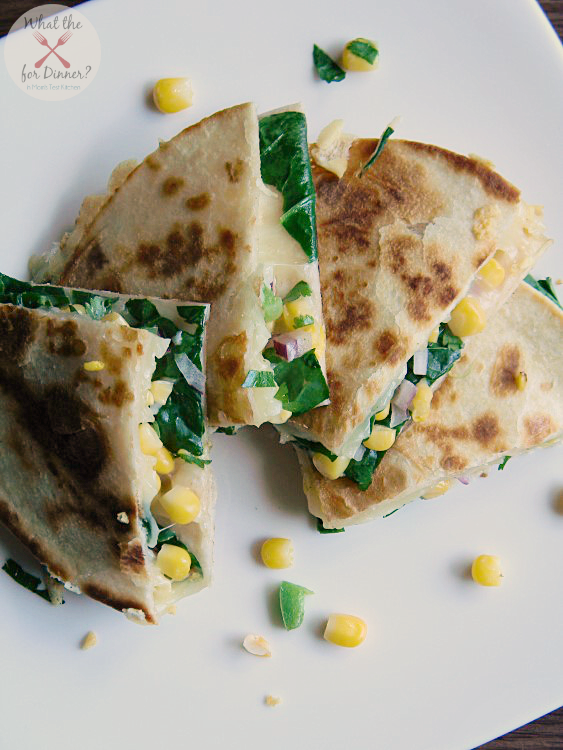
[32,104,328,426]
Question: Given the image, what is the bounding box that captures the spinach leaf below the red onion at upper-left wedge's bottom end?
[262,348,329,415]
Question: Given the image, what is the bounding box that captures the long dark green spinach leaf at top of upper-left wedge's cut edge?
[259,112,317,262]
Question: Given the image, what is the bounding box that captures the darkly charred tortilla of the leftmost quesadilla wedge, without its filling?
[0,277,215,623]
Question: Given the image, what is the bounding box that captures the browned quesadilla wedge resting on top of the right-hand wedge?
[280,126,549,490]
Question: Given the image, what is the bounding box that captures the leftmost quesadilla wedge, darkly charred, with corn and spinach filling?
[0,274,215,623]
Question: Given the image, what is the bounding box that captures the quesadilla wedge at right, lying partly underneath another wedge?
[298,283,563,528]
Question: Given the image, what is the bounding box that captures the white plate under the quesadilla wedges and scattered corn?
[0,0,563,750]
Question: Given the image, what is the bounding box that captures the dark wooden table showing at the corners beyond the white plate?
[0,0,563,750]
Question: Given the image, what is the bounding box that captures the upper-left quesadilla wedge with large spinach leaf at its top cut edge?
[32,104,328,427]
